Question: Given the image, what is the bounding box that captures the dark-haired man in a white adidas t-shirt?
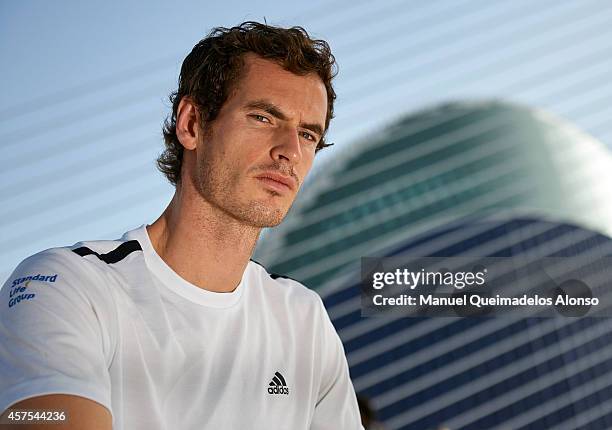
[0,22,361,430]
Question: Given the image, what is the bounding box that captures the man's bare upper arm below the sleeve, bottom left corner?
[0,394,112,430]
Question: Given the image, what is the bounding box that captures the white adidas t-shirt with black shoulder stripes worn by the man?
[0,226,362,430]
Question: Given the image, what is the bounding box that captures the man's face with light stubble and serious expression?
[191,54,327,228]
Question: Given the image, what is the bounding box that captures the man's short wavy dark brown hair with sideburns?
[157,21,337,186]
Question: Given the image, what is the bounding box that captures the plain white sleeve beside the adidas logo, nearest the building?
[310,295,363,430]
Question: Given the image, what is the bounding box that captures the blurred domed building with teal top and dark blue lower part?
[255,102,612,430]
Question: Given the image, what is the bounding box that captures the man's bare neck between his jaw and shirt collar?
[147,186,261,293]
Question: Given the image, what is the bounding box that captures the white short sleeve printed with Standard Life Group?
[0,248,112,412]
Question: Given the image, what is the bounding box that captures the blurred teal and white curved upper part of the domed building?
[256,101,612,288]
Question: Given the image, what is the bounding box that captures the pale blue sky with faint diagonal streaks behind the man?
[0,0,612,280]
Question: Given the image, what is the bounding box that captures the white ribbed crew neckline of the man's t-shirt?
[124,224,249,308]
